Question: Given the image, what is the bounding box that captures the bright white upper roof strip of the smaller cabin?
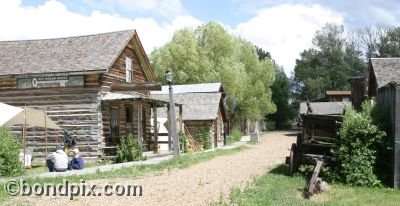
[150,83,222,94]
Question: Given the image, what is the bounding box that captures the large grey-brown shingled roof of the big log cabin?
[0,30,135,75]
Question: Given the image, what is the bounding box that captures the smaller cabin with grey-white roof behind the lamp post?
[150,83,228,148]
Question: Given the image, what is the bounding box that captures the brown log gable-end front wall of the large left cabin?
[101,42,152,155]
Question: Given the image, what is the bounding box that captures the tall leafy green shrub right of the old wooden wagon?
[331,102,385,186]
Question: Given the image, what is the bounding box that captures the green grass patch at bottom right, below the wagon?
[214,165,400,206]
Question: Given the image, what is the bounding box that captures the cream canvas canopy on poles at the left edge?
[0,102,62,166]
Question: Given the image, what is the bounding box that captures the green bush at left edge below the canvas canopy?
[0,128,22,177]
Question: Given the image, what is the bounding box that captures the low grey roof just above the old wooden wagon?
[300,102,351,115]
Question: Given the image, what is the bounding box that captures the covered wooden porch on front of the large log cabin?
[101,92,182,157]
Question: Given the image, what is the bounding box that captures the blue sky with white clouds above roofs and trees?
[0,0,400,76]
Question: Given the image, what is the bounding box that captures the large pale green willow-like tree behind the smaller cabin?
[150,22,276,119]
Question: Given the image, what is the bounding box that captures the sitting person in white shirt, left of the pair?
[46,145,68,172]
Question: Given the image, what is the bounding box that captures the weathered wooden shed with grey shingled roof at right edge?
[368,58,400,188]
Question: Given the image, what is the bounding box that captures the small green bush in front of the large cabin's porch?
[116,135,144,163]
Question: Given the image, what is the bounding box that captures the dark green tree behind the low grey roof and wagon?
[293,24,366,100]
